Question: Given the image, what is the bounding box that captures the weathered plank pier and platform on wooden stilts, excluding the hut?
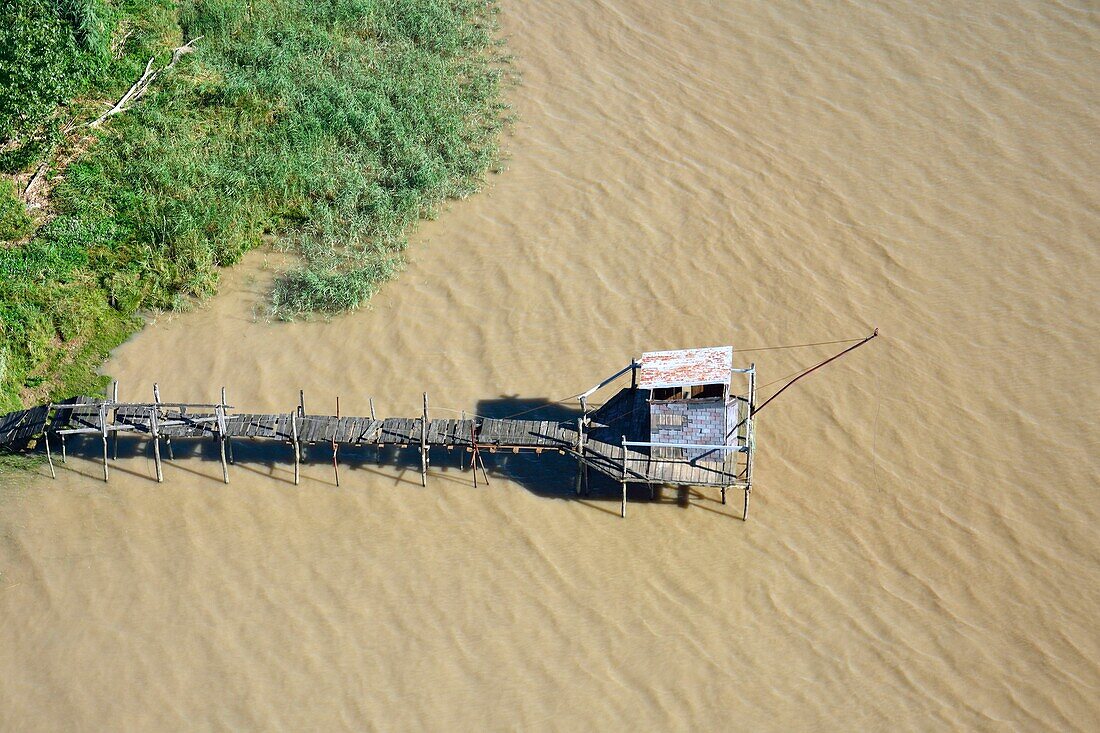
[0,352,756,516]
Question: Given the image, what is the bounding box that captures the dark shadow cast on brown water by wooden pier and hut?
[52,396,736,518]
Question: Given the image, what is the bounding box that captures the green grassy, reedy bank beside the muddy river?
[0,0,505,411]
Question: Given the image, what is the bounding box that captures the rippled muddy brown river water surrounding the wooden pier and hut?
[0,0,1100,731]
